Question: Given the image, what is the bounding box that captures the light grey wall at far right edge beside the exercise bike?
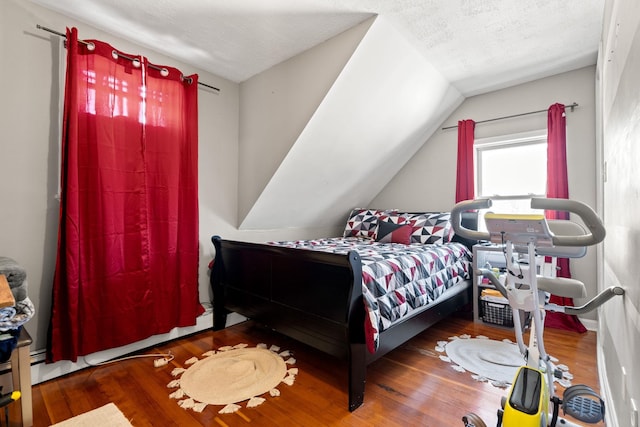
[597,0,640,426]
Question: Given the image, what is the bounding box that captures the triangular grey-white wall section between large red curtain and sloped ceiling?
[238,18,375,222]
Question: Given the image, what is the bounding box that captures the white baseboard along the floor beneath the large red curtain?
[11,310,246,385]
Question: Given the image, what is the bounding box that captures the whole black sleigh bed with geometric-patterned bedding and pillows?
[211,209,477,411]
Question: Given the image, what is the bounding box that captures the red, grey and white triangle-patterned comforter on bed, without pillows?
[270,237,471,353]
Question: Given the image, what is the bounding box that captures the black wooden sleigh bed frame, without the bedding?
[211,216,472,411]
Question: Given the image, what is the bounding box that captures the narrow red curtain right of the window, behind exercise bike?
[545,104,587,332]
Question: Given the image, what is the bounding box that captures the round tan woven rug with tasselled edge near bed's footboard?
[168,344,298,413]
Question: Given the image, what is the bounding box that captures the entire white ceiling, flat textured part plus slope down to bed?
[26,0,604,229]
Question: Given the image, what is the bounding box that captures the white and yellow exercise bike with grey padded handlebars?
[451,198,624,427]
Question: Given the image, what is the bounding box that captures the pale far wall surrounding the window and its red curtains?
[371,67,596,319]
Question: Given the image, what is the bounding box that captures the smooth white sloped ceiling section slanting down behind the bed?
[240,17,463,229]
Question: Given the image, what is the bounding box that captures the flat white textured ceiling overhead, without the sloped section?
[26,0,604,96]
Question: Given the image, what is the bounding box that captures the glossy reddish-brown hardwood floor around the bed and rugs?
[33,316,604,427]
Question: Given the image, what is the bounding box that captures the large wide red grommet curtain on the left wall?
[47,28,203,362]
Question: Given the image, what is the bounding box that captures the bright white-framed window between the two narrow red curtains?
[474,129,547,222]
